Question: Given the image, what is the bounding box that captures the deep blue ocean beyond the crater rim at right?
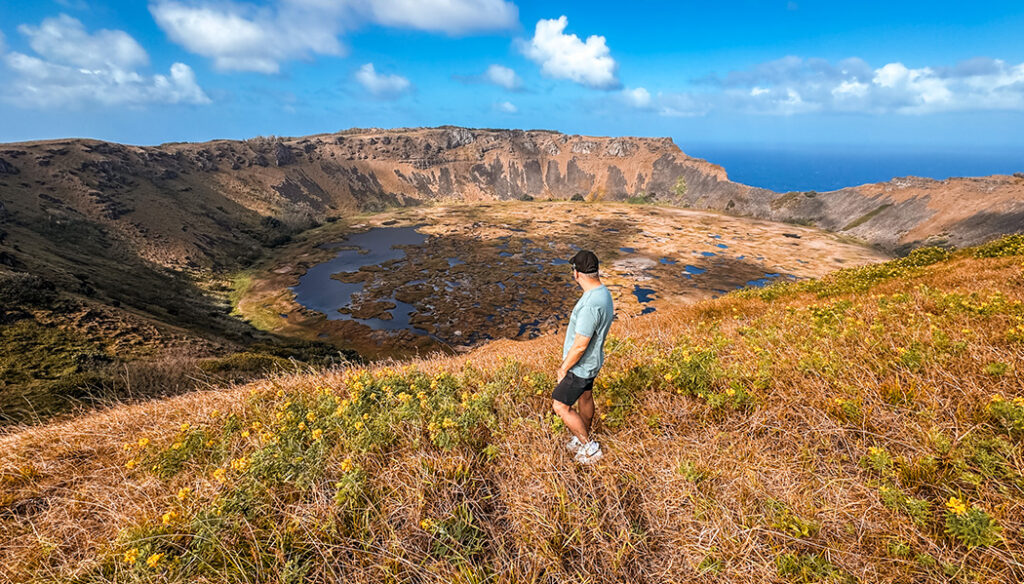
[677,140,1024,193]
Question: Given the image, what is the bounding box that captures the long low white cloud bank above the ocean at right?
[638,56,1024,116]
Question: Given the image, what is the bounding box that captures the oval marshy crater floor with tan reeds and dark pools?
[237,202,887,357]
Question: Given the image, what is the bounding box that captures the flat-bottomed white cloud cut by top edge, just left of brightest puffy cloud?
[355,0,519,36]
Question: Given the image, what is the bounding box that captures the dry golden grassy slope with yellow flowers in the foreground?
[0,236,1024,582]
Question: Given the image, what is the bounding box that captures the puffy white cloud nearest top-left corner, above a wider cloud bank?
[17,14,150,69]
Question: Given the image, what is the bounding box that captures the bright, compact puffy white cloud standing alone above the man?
[520,15,622,89]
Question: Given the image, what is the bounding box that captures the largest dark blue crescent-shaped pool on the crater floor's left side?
[292,227,427,333]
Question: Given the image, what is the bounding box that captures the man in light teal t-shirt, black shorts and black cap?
[551,250,614,464]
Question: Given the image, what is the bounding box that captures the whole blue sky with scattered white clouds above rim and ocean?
[0,0,1024,152]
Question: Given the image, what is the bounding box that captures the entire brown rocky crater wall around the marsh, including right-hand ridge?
[0,127,1024,284]
